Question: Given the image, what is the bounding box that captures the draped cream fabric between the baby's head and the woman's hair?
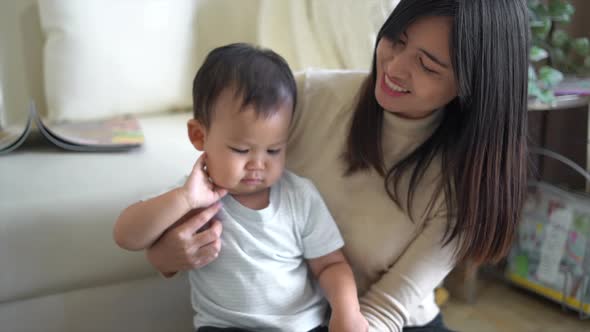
[258,0,398,70]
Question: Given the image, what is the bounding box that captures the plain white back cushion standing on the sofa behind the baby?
[39,0,197,120]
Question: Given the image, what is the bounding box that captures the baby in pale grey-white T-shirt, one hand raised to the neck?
[114,44,367,332]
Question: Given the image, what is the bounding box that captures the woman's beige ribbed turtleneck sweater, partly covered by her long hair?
[287,71,455,332]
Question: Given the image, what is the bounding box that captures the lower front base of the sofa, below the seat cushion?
[0,274,194,332]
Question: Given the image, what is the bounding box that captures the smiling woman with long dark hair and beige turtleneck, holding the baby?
[147,0,528,331]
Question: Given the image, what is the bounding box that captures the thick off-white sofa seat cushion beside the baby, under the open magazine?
[0,113,198,303]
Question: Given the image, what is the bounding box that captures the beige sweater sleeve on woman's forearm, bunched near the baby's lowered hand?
[360,217,456,332]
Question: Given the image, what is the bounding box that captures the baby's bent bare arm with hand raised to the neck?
[113,153,227,250]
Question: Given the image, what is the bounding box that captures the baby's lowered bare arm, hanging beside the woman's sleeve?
[308,250,368,332]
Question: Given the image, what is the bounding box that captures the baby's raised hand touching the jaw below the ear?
[180,152,227,209]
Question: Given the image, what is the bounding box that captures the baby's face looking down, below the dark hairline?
[203,89,292,195]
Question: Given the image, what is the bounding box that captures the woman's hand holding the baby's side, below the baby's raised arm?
[146,203,222,277]
